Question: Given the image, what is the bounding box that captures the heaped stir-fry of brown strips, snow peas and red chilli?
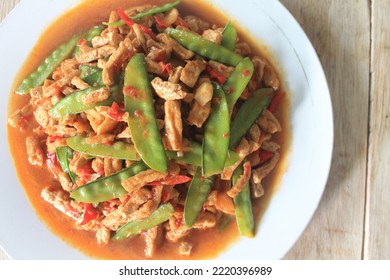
[8,1,284,257]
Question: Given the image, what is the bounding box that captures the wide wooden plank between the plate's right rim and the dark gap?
[281,0,372,259]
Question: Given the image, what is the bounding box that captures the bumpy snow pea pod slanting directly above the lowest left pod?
[70,162,148,203]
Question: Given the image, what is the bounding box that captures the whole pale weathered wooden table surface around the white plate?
[0,0,390,259]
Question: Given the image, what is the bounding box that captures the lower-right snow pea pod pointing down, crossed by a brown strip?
[233,164,255,237]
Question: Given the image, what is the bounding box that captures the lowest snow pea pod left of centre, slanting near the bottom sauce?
[111,202,175,240]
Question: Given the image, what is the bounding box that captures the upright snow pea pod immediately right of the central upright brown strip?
[202,83,230,177]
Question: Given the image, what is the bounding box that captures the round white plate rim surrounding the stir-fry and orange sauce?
[0,0,333,259]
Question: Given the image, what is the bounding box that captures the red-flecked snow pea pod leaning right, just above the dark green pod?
[223,57,254,113]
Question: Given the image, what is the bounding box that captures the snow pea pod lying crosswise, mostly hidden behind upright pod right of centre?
[166,141,240,167]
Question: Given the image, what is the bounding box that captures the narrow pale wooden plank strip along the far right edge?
[364,0,390,260]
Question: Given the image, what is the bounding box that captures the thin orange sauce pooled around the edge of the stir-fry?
[8,0,290,259]
